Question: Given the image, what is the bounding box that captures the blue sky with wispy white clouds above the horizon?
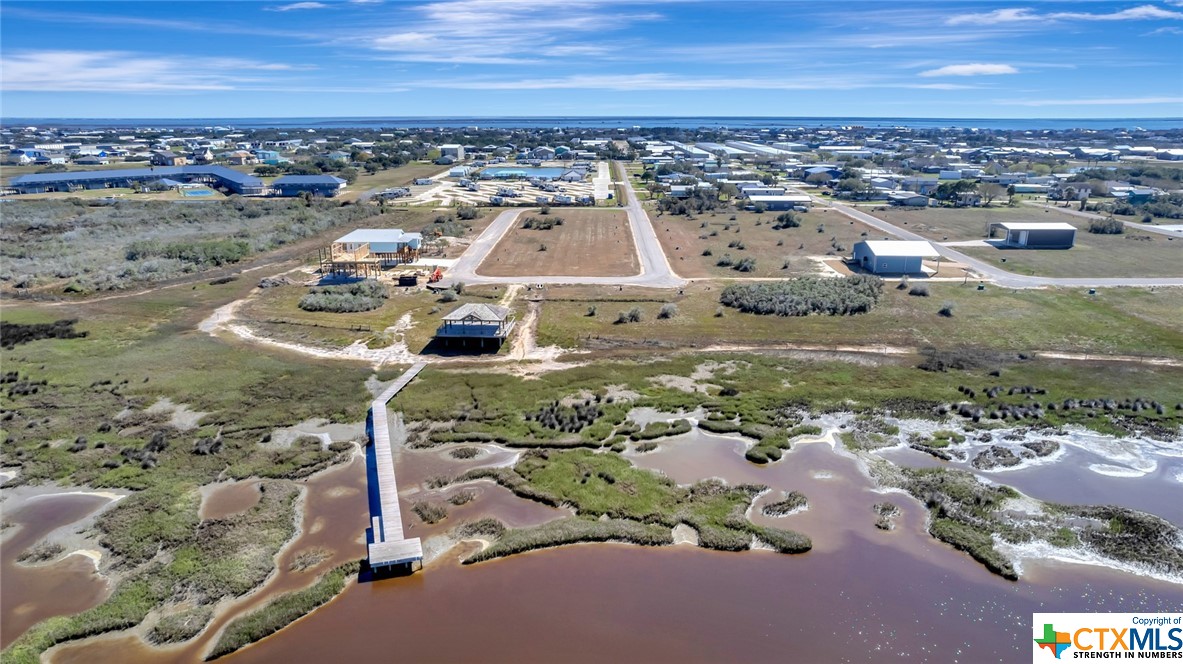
[0,0,1183,118]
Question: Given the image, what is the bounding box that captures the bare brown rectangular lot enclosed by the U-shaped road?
[478,208,641,277]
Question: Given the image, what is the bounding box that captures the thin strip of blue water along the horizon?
[0,116,1183,130]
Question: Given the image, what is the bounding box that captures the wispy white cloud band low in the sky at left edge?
[0,51,295,92]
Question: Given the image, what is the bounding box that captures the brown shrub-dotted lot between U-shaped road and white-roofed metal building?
[649,209,887,277]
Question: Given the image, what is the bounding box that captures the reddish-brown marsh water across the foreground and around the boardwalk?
[16,431,1183,663]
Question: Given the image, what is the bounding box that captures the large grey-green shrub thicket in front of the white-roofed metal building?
[719,275,883,316]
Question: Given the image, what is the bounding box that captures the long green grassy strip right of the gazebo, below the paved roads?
[538,281,1183,356]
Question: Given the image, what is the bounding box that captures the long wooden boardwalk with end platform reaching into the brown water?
[369,362,427,570]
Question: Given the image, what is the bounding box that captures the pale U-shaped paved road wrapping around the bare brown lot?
[440,166,686,288]
